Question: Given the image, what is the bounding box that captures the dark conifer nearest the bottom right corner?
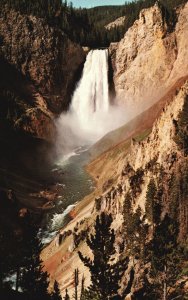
[149,215,182,299]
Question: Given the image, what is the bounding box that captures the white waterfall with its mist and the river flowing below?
[46,50,126,242]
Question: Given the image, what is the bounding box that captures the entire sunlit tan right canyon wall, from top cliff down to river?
[42,4,188,299]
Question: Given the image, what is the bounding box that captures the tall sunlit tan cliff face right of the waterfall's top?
[109,4,188,111]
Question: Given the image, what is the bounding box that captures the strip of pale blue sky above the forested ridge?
[68,0,125,8]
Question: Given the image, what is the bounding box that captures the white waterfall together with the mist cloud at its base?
[56,50,125,155]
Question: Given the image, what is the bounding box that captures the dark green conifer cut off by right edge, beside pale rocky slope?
[174,95,188,155]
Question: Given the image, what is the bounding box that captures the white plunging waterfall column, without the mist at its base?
[70,50,109,125]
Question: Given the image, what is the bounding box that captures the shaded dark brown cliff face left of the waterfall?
[0,7,85,139]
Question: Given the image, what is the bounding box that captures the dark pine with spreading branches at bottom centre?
[79,213,132,300]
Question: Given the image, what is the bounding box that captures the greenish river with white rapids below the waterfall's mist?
[42,147,94,244]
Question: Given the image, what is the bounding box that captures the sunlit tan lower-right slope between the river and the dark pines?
[42,76,188,299]
